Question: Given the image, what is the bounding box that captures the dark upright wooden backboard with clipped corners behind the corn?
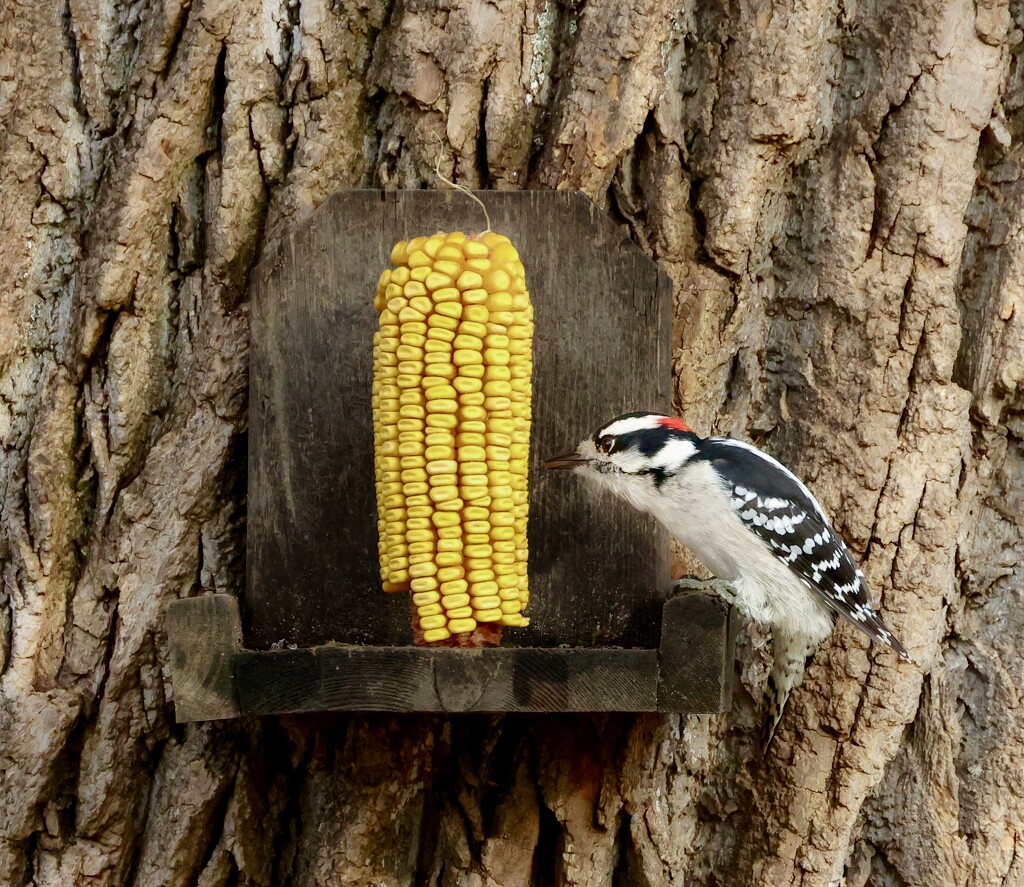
[246,191,671,648]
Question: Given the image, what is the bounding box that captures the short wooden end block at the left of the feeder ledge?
[166,594,242,724]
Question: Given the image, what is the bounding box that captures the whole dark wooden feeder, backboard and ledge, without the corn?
[168,191,732,721]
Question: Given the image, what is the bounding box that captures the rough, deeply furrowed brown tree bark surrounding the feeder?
[0,0,1024,887]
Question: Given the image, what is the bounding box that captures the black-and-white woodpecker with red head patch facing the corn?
[544,413,909,747]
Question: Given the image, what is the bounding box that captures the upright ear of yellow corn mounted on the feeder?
[373,231,534,642]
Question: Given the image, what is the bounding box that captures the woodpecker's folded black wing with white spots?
[701,437,909,660]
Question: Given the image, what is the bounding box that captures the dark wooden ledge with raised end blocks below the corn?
[167,580,734,723]
